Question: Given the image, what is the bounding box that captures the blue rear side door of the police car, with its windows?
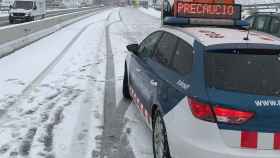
[152,35,193,113]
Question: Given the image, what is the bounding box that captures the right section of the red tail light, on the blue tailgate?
[214,106,254,124]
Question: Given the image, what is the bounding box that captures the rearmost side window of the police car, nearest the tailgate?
[172,40,193,74]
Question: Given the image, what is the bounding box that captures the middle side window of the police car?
[154,33,177,66]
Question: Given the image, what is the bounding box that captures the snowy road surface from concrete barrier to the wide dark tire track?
[0,8,114,158]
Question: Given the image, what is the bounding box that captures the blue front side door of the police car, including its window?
[129,31,163,122]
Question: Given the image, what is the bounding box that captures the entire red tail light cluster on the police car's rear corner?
[188,98,254,124]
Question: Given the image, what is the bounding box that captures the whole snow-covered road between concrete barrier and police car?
[0,8,160,158]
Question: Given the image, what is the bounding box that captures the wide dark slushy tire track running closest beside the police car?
[100,10,135,158]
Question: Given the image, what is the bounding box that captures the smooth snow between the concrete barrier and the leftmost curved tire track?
[0,12,95,109]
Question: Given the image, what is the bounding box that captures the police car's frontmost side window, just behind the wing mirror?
[138,31,162,57]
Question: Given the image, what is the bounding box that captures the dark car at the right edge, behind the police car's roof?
[246,13,280,37]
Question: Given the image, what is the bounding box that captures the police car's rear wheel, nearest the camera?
[153,110,171,158]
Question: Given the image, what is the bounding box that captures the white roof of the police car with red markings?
[163,26,280,47]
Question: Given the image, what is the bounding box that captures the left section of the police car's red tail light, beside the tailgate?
[188,98,215,122]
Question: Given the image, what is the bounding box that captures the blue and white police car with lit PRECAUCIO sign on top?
[123,1,280,158]
